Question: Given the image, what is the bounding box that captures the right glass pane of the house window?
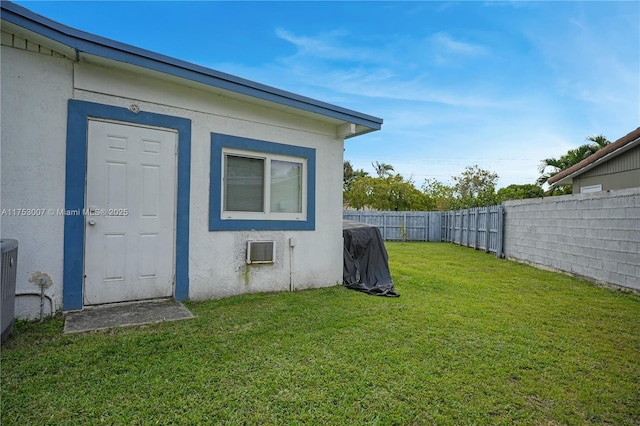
[270,160,302,213]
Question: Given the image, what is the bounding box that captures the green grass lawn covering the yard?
[1,243,640,425]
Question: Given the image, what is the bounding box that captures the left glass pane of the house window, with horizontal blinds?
[224,155,264,212]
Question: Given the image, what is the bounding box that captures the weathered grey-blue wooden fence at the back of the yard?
[342,206,504,257]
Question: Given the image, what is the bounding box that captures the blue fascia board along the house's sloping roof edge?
[1,0,382,137]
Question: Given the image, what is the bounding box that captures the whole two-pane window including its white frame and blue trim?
[209,133,315,231]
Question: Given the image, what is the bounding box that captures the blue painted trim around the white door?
[62,99,191,311]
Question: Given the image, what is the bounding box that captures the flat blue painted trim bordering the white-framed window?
[209,133,316,231]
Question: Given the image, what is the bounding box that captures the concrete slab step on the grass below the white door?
[64,300,194,333]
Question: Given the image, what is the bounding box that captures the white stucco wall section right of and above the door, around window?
[75,64,343,300]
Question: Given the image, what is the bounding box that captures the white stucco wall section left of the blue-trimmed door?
[0,46,73,317]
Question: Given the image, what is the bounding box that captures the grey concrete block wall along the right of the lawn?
[504,188,640,290]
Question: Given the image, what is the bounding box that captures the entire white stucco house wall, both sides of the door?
[2,47,343,317]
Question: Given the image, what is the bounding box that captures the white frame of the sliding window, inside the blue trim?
[220,147,308,221]
